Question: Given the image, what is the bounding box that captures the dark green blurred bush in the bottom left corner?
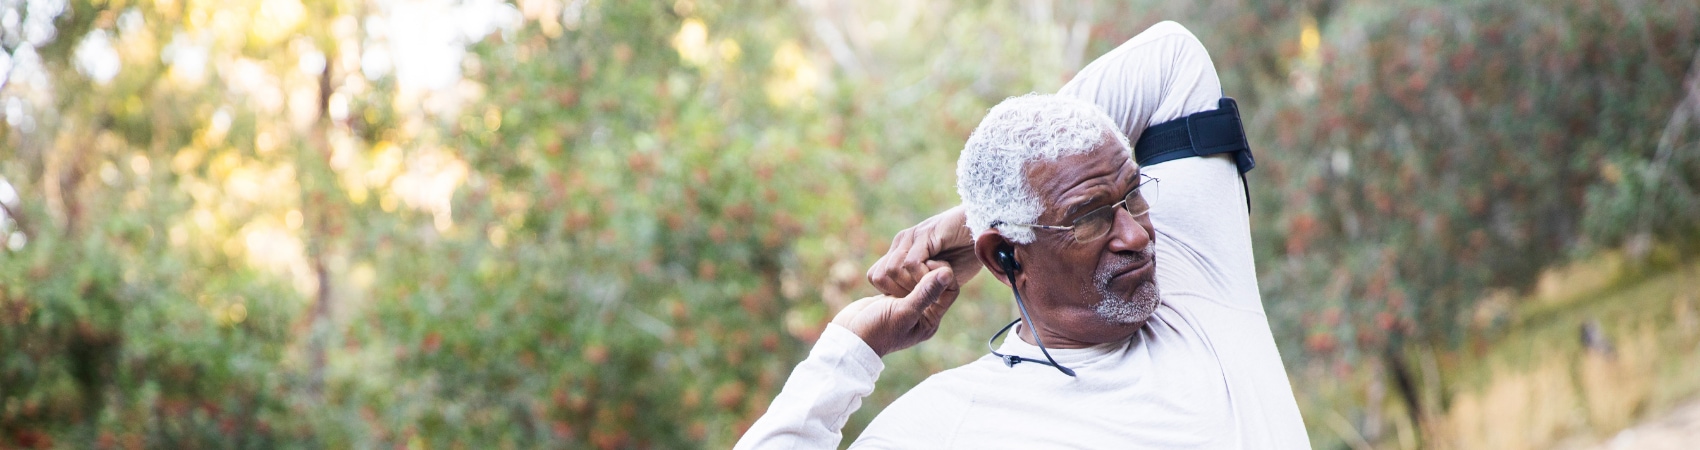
[0,180,299,448]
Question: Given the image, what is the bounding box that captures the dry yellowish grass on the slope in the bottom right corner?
[1431,258,1700,448]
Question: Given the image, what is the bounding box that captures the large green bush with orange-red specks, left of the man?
[363,3,1060,447]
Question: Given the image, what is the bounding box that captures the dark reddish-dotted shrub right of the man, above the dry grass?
[1253,2,1700,358]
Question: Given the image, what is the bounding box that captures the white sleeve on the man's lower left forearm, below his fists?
[733,324,886,448]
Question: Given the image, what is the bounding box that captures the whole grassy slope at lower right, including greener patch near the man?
[1292,255,1700,448]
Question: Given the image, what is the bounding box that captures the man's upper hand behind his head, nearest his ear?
[867,205,983,297]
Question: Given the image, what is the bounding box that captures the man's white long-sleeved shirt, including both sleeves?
[738,22,1309,448]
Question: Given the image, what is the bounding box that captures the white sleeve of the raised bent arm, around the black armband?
[1057,22,1263,314]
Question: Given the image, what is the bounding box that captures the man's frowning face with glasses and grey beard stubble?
[1018,136,1158,346]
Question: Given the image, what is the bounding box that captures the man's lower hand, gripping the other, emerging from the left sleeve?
[833,267,961,357]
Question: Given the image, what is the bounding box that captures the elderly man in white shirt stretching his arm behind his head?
[738,22,1309,448]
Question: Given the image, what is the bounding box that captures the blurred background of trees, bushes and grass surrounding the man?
[0,0,1700,448]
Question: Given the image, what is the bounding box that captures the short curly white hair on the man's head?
[957,93,1132,245]
